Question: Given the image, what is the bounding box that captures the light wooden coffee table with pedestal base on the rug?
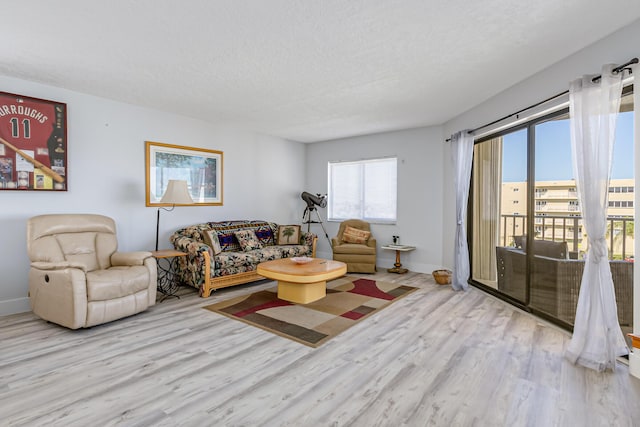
[257,258,347,304]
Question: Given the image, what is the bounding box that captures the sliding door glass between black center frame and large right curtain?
[527,113,586,324]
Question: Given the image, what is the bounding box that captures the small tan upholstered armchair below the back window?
[331,219,376,273]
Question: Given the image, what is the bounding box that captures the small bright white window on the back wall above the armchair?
[328,157,398,223]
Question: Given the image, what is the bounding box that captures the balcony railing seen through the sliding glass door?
[500,215,634,259]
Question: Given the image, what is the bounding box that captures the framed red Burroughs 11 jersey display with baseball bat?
[0,92,68,191]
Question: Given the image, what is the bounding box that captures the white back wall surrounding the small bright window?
[308,126,446,273]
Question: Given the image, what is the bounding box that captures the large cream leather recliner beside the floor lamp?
[27,214,157,329]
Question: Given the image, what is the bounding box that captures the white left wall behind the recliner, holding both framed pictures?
[0,77,305,316]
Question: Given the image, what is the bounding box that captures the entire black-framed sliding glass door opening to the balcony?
[469,88,635,342]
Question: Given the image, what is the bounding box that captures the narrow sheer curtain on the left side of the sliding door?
[451,130,473,291]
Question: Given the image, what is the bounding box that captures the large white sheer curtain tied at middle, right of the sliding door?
[565,65,628,371]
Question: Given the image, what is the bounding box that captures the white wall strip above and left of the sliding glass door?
[442,20,640,270]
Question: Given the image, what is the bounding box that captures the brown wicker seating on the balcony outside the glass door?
[496,241,633,325]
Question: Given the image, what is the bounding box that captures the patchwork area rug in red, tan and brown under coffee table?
[203,276,418,347]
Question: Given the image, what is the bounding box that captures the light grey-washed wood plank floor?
[0,272,640,427]
